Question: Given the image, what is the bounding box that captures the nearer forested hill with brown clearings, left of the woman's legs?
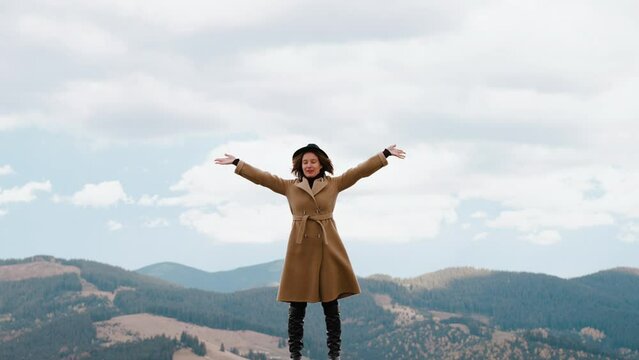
[0,256,287,360]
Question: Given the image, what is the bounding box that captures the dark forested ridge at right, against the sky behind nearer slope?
[368,268,639,358]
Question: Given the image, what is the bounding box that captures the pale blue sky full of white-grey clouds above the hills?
[0,0,639,278]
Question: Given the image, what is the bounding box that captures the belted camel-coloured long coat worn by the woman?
[235,153,388,302]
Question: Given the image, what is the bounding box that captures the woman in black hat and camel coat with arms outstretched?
[215,144,405,360]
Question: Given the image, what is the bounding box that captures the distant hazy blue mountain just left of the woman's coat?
[136,260,284,293]
